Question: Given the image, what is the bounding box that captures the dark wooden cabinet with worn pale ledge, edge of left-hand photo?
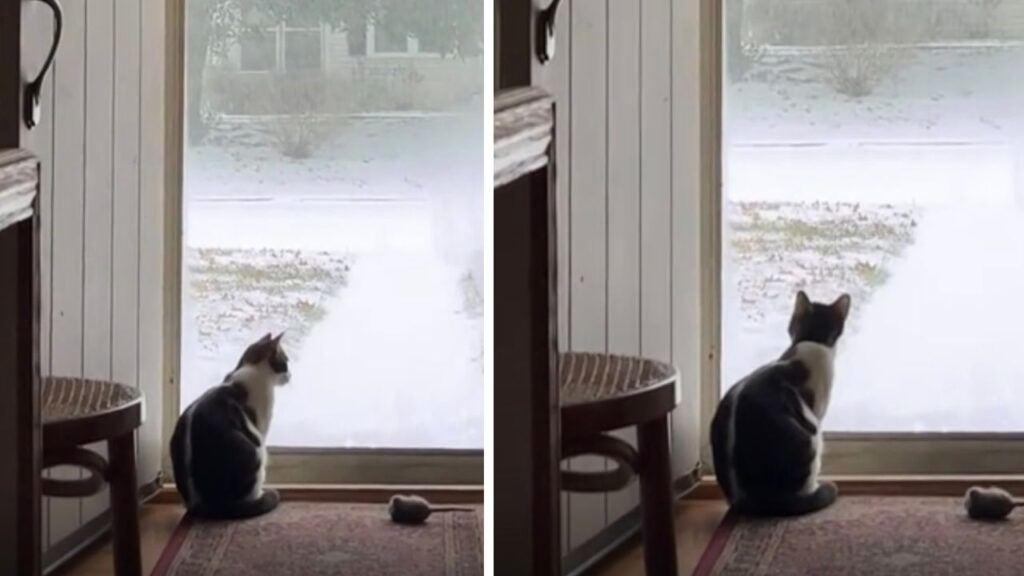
[0,0,42,576]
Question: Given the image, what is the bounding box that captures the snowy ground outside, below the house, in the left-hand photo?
[182,102,484,448]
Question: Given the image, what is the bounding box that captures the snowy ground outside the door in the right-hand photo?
[723,47,1024,431]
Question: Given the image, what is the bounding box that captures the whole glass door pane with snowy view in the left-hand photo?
[180,0,486,449]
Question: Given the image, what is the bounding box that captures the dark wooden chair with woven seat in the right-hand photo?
[559,353,679,576]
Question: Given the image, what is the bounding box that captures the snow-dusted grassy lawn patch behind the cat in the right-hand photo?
[722,202,921,383]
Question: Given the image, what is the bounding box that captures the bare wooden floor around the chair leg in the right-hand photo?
[594,500,727,576]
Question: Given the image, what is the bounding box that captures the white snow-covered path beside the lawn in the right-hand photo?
[827,204,1024,431]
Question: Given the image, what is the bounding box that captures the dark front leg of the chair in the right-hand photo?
[637,416,678,576]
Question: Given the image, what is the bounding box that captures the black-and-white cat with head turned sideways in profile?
[171,333,291,519]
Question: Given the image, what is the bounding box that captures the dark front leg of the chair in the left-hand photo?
[108,433,142,576]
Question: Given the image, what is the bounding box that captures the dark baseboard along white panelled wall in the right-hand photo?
[562,462,701,576]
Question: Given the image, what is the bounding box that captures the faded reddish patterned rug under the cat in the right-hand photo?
[693,496,1024,576]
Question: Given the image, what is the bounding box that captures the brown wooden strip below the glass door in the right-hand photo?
[686,476,1024,500]
